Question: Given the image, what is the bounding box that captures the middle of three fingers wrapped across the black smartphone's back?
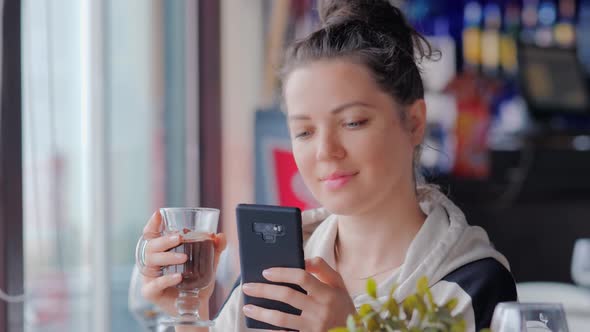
[242,283,316,310]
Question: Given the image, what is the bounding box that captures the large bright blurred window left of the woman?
[22,0,199,332]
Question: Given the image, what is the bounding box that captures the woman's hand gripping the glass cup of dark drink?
[141,211,226,315]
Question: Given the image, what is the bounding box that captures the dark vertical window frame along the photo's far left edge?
[0,0,24,331]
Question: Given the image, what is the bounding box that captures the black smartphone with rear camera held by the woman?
[236,204,305,331]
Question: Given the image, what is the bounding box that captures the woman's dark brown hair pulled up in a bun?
[281,0,440,109]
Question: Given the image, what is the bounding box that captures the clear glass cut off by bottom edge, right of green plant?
[490,302,568,332]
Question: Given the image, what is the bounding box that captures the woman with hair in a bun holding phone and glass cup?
[144,0,516,331]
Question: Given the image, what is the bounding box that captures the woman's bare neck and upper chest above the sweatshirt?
[336,184,426,278]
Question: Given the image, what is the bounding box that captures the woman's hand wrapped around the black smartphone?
[242,257,356,332]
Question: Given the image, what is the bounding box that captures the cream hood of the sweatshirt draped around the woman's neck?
[302,186,510,302]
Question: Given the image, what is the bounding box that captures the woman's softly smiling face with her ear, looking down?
[284,59,425,215]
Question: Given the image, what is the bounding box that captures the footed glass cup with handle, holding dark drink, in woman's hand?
[136,208,219,326]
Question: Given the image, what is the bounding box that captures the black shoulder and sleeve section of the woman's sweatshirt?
[443,258,517,331]
